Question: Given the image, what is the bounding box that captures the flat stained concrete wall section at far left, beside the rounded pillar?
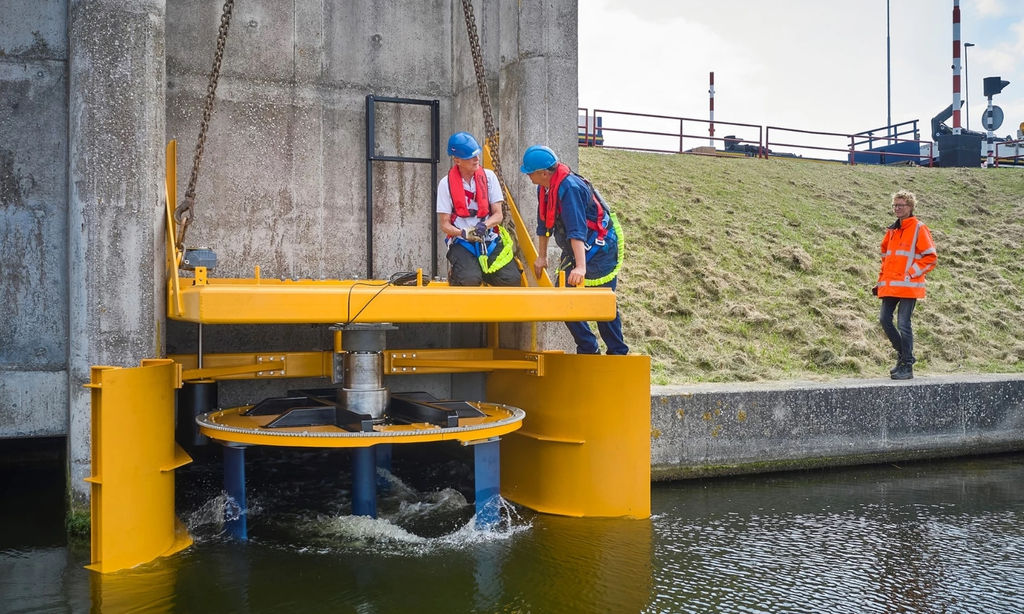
[0,0,68,437]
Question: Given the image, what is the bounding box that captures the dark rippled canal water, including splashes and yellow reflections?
[0,446,1024,614]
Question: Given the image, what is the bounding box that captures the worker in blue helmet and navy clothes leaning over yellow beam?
[519,145,630,354]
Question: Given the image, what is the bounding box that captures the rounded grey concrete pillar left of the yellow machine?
[68,0,165,507]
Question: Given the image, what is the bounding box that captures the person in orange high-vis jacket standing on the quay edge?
[871,189,938,380]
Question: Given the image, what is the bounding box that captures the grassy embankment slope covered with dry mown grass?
[580,149,1024,384]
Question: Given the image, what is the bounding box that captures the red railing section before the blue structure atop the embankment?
[765,126,935,166]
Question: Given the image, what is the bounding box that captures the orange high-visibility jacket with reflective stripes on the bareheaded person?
[878,216,939,299]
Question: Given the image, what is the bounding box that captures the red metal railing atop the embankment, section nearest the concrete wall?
[577,106,764,157]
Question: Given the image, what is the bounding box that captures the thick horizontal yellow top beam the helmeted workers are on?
[168,277,615,324]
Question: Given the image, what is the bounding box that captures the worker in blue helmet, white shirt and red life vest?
[436,132,522,286]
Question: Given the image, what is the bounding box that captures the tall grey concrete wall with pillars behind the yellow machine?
[0,0,577,503]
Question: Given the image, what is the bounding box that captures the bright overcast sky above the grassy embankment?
[579,0,1024,152]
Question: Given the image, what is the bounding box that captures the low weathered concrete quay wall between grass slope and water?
[651,375,1024,480]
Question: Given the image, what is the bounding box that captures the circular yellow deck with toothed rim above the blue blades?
[196,401,526,447]
